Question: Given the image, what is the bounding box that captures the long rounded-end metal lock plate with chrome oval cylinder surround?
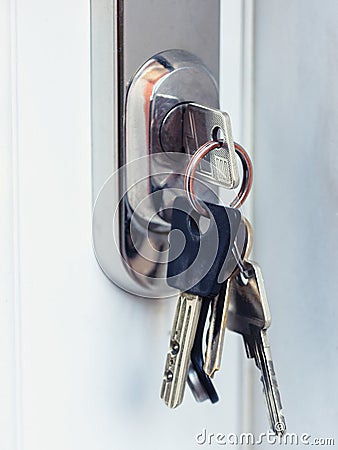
[92,0,236,298]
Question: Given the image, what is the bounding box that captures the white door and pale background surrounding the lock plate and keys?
[0,0,338,450]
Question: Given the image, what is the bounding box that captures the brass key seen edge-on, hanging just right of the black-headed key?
[203,217,252,378]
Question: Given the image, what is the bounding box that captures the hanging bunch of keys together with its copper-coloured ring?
[161,141,286,435]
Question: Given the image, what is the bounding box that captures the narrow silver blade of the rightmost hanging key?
[254,330,286,436]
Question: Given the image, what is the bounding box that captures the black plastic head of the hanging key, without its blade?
[167,197,241,297]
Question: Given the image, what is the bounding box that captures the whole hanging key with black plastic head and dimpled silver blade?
[161,197,241,408]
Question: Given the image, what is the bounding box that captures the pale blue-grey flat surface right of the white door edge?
[255,0,338,442]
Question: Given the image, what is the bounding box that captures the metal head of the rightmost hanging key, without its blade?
[227,261,271,335]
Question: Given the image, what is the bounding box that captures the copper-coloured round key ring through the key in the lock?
[184,141,253,216]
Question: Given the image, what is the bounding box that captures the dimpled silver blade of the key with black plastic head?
[161,293,202,408]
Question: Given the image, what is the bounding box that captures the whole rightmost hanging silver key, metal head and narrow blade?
[227,261,286,435]
